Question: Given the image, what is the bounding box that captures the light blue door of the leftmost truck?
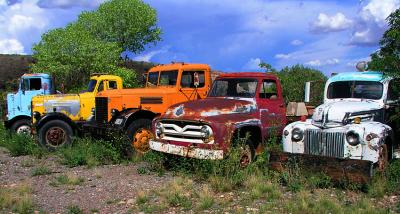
[21,77,44,115]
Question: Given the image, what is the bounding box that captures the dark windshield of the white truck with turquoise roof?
[327,81,383,100]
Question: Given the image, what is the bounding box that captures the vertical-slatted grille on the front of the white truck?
[304,130,346,157]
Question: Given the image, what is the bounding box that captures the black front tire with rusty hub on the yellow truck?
[38,120,73,151]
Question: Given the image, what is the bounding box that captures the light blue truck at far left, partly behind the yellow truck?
[3,73,55,134]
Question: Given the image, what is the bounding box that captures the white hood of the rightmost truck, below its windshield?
[312,100,382,126]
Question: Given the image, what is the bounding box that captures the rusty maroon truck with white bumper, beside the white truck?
[150,72,286,164]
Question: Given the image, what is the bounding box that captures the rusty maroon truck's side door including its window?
[258,79,286,135]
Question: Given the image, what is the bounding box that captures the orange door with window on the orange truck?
[179,70,208,101]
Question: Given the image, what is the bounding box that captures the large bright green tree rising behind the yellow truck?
[32,0,160,90]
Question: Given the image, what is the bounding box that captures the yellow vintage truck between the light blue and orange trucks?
[31,74,122,150]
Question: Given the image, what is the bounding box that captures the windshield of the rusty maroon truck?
[208,78,257,97]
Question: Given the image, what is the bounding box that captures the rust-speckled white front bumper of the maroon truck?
[150,140,224,160]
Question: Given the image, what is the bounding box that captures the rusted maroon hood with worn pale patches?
[163,98,257,121]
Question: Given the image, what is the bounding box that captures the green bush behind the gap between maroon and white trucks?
[260,62,327,105]
